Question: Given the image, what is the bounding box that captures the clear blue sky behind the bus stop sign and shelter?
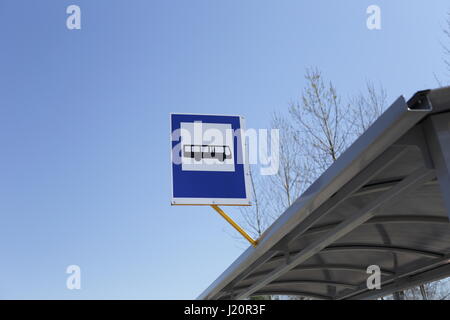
[0,0,450,299]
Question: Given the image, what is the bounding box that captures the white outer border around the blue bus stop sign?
[169,112,252,206]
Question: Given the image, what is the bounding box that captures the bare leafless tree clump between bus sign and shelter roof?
[241,68,386,242]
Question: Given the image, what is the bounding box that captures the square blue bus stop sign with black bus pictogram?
[170,114,251,206]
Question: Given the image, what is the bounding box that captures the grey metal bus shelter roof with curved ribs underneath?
[198,87,450,299]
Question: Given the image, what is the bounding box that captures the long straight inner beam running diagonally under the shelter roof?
[237,168,435,299]
